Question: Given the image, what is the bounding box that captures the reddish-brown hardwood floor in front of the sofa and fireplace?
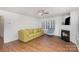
[1,35,78,52]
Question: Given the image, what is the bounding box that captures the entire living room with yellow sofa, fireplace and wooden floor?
[0,7,79,52]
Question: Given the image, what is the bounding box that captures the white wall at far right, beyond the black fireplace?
[71,11,79,48]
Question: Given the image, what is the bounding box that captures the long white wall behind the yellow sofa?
[0,10,39,43]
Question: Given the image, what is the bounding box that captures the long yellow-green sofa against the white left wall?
[18,28,43,42]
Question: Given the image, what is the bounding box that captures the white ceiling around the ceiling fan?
[0,7,79,17]
